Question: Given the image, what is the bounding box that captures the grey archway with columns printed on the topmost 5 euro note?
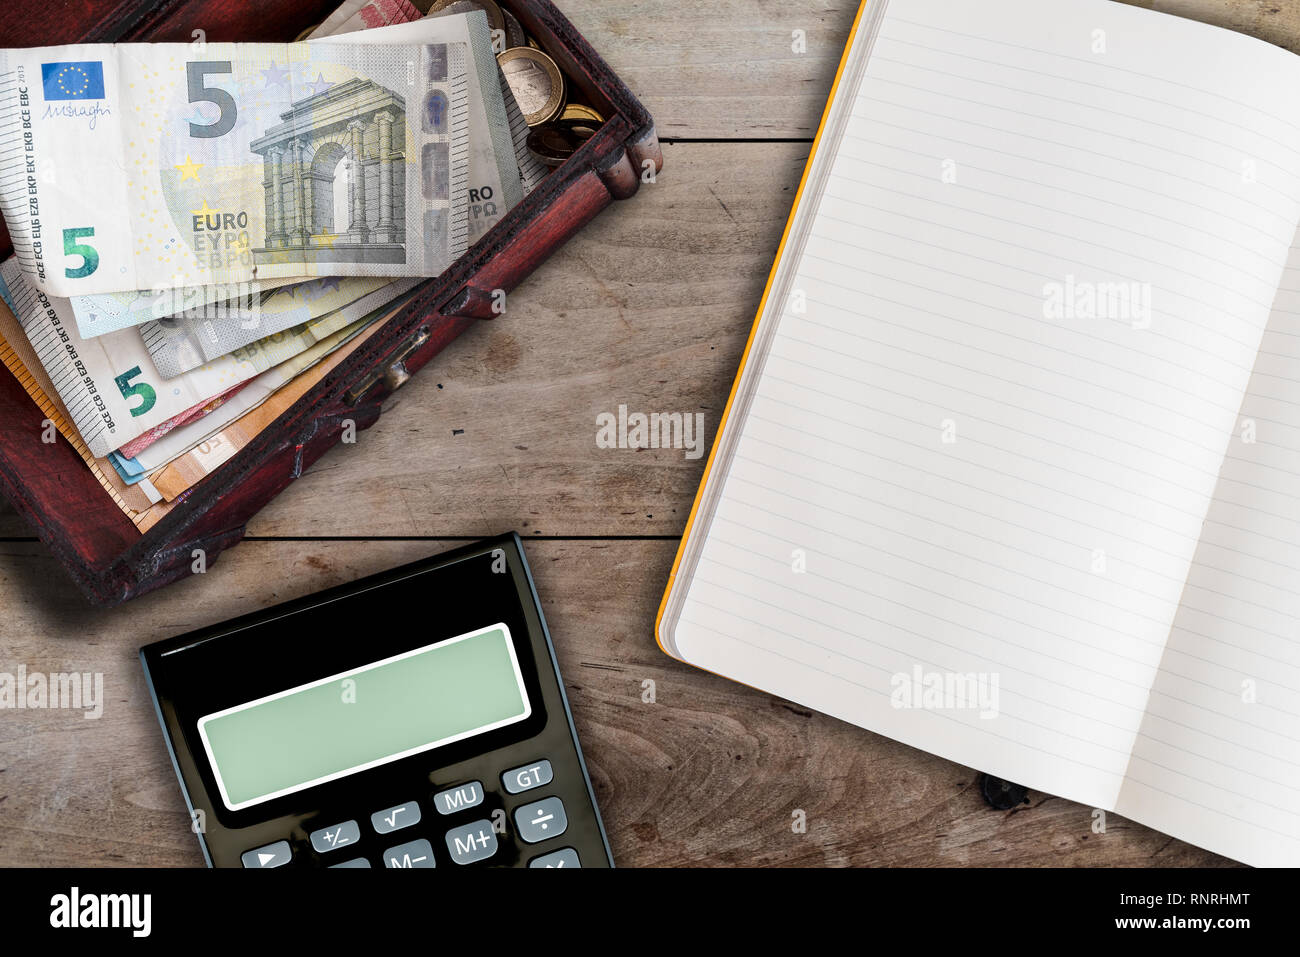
[248,79,407,263]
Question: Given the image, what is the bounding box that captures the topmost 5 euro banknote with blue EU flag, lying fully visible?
[0,34,469,298]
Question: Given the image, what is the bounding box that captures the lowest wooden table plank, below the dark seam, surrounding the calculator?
[0,541,1218,866]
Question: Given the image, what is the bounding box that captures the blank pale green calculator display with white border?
[199,623,533,811]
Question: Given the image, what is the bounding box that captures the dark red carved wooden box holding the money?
[0,0,663,605]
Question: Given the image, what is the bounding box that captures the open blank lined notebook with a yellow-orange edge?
[658,0,1300,866]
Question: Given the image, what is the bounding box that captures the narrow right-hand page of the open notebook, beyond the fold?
[1115,233,1300,866]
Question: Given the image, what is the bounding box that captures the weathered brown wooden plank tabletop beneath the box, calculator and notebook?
[0,0,1279,866]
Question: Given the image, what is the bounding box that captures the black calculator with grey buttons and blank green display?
[140,534,614,870]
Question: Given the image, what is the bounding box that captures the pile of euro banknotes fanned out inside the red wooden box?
[0,0,547,532]
